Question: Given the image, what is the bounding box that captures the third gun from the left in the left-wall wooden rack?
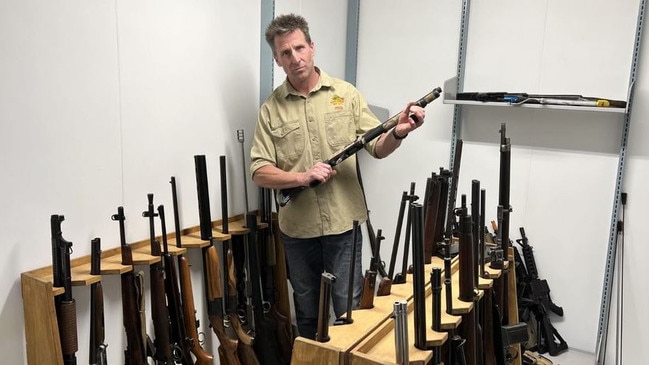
[111,207,150,365]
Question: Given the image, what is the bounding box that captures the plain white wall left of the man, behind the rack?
[0,0,260,364]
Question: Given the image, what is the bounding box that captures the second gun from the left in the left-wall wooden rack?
[88,238,107,365]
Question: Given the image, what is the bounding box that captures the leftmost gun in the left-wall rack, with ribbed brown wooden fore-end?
[50,214,79,365]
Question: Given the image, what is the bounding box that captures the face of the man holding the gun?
[274,29,315,82]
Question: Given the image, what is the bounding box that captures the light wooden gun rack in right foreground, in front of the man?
[291,251,520,365]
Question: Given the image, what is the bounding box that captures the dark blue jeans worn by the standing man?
[282,227,363,339]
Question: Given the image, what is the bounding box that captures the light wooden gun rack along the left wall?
[20,215,290,365]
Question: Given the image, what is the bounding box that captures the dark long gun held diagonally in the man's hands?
[278,87,442,207]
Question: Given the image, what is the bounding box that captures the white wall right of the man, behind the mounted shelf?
[357,0,647,363]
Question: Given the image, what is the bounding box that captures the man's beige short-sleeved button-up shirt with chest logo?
[250,70,380,238]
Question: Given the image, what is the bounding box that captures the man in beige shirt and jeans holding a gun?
[250,14,424,339]
